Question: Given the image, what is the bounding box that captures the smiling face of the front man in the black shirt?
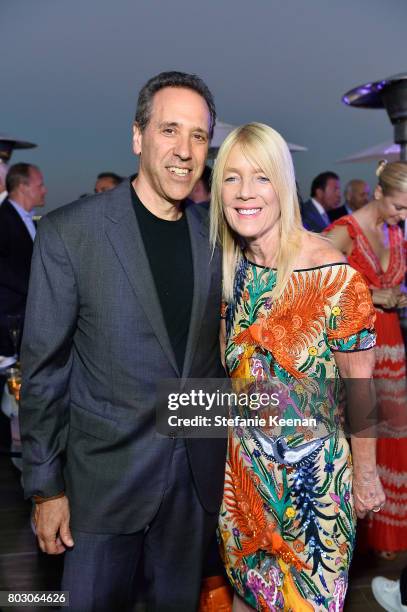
[133,87,210,205]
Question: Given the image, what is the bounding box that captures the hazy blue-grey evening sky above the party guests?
[0,0,407,212]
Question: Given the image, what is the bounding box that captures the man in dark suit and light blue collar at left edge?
[0,163,47,355]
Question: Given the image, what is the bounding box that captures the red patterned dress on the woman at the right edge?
[333,215,407,551]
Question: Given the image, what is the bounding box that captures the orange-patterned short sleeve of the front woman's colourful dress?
[325,265,376,352]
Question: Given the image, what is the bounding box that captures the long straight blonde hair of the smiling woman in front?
[210,123,306,301]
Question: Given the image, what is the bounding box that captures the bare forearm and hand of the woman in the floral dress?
[334,348,385,518]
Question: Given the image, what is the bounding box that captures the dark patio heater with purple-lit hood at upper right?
[342,72,407,161]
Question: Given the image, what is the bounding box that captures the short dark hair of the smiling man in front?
[134,71,216,138]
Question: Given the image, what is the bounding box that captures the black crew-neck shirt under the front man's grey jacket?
[131,188,194,372]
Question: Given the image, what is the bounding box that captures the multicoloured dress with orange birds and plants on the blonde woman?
[219,259,375,612]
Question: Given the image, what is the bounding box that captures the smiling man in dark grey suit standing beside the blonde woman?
[20,72,226,612]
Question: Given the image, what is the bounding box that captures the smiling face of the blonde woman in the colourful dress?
[222,145,280,241]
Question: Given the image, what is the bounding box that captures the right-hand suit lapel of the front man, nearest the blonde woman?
[182,204,211,378]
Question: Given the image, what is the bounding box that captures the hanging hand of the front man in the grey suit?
[34,495,74,555]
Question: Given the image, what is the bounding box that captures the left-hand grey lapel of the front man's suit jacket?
[105,181,180,376]
